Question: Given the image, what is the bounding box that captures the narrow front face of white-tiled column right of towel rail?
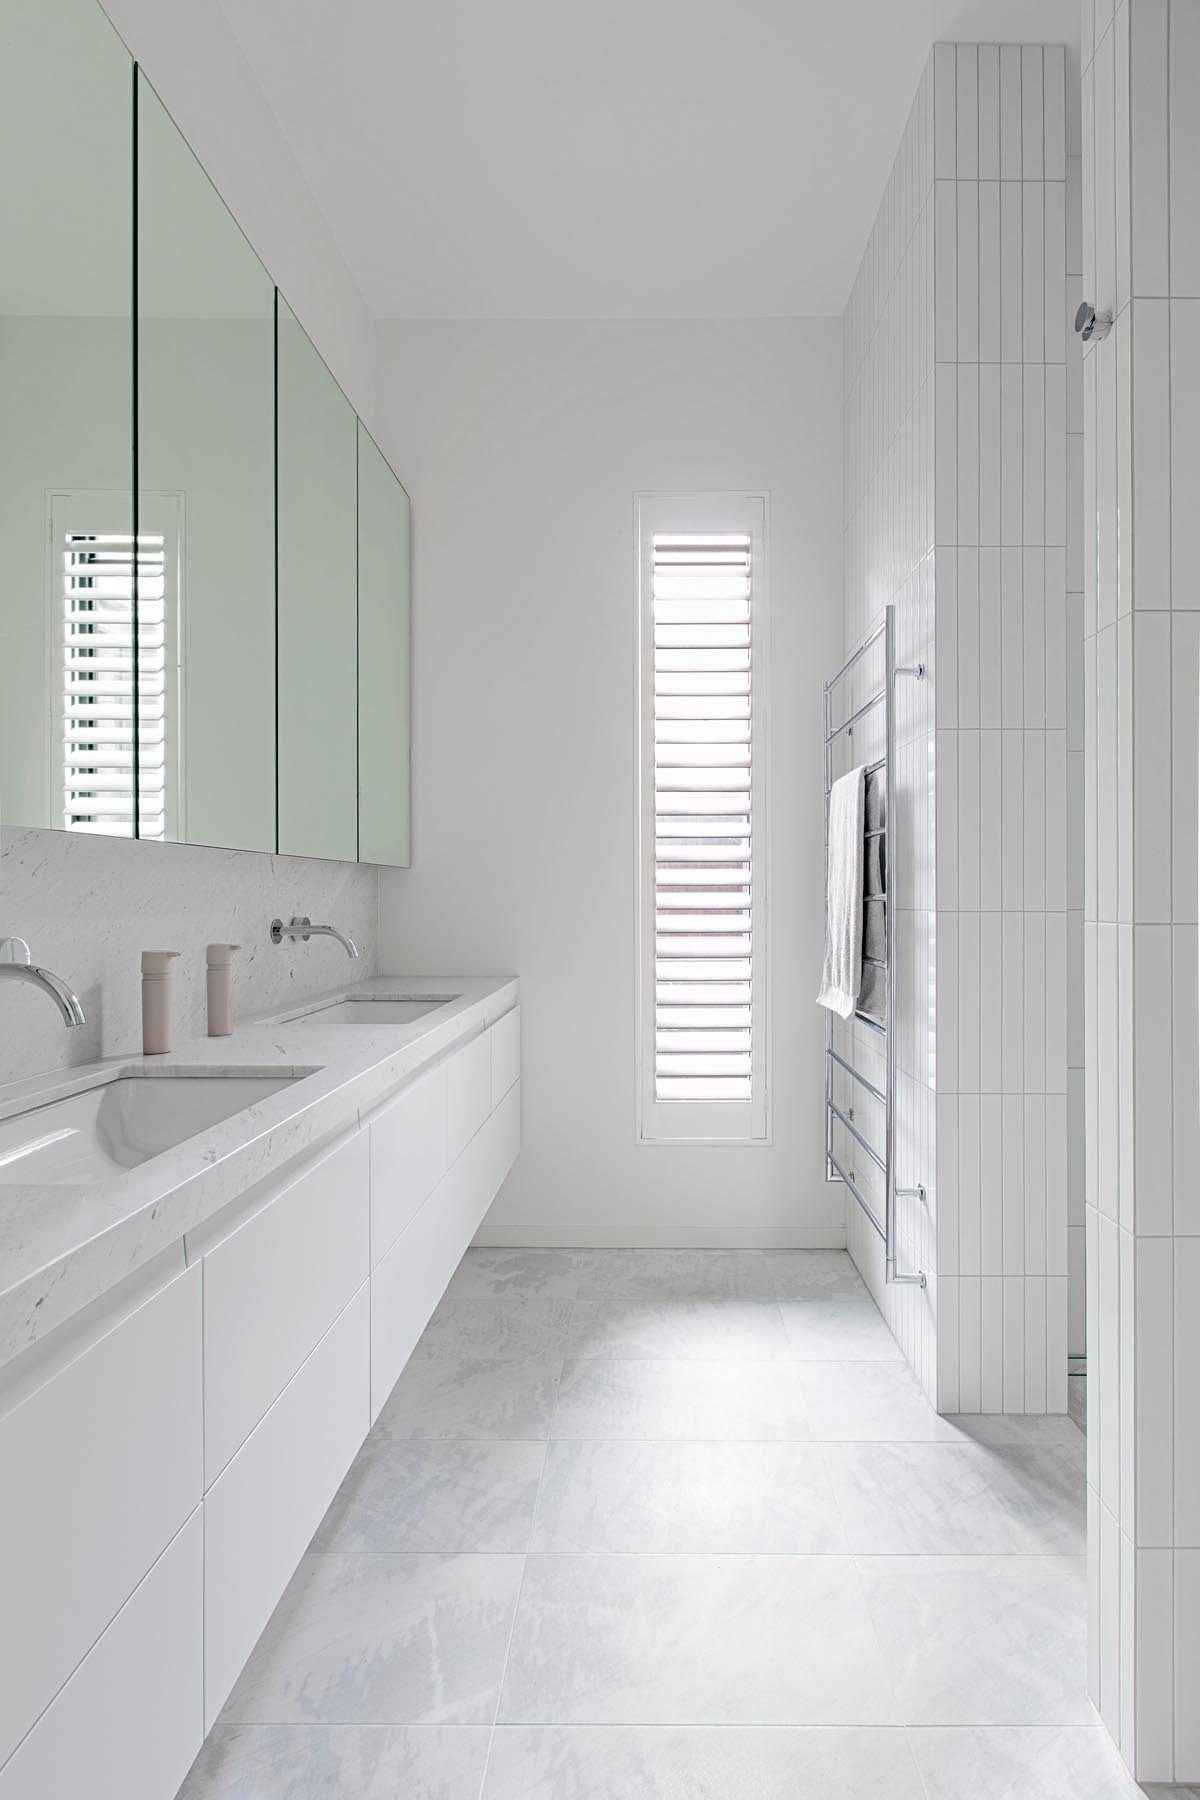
[934,43,1083,1413]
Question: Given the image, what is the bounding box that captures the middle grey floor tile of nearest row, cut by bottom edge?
[482,1724,923,1800]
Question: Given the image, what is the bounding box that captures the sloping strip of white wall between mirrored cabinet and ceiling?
[104,0,376,427]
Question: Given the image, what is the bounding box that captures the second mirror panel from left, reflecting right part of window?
[137,70,275,850]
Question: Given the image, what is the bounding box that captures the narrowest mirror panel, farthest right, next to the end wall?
[358,419,412,868]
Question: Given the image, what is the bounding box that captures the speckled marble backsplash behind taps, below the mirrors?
[0,828,380,1084]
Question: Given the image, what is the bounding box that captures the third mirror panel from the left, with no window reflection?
[275,295,358,862]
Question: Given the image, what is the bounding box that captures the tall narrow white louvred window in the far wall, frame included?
[639,495,766,1139]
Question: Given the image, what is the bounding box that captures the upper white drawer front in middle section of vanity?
[203,1132,371,1489]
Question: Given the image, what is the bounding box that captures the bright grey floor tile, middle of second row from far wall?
[565,1294,791,1363]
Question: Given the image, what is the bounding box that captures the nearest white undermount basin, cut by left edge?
[0,1075,299,1186]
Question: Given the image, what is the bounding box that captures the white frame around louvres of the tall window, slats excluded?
[635,491,772,1145]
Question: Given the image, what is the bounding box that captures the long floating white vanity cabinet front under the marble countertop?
[0,1010,520,1800]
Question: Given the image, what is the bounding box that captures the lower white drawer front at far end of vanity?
[371,1084,520,1422]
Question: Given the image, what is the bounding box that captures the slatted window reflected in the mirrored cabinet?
[52,495,178,839]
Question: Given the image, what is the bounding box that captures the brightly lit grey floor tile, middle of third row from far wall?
[551,1357,813,1440]
